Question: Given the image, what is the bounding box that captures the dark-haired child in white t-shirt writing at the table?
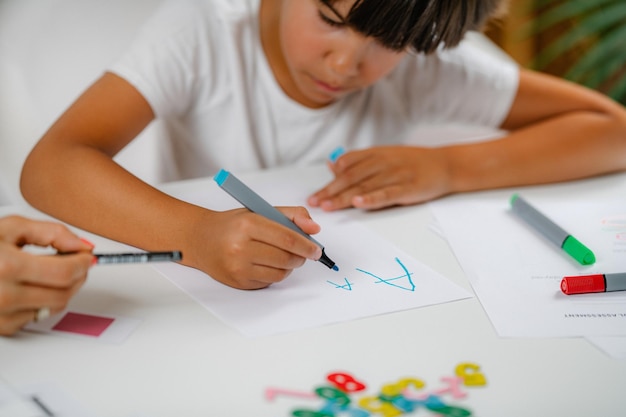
[22,0,626,289]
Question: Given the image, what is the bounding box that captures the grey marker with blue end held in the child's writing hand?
[213,169,339,271]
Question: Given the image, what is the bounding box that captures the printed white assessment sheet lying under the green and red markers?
[429,196,626,337]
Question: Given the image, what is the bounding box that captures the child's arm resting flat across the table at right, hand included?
[309,70,626,210]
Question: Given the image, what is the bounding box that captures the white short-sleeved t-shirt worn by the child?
[110,0,518,179]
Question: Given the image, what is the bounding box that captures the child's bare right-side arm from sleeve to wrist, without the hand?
[450,70,626,192]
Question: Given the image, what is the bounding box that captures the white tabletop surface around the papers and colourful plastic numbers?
[0,167,626,417]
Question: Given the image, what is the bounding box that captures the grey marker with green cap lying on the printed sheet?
[511,194,596,265]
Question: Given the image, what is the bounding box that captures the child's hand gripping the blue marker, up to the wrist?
[184,207,322,290]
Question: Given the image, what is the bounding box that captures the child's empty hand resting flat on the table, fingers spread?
[307,146,451,211]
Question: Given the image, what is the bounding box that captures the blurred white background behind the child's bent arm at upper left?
[0,0,166,205]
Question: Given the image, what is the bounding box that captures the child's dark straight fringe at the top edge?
[320,0,504,53]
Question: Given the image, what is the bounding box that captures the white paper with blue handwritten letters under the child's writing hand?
[155,178,471,337]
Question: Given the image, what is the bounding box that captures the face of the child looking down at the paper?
[264,0,405,108]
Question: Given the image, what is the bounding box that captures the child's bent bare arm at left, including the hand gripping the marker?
[21,73,321,289]
